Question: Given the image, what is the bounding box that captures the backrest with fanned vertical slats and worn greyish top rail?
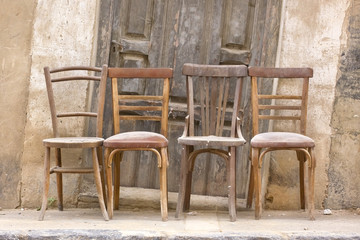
[182,63,247,137]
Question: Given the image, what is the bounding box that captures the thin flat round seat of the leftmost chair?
[43,137,104,148]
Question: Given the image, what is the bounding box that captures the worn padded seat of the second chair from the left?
[104,131,168,148]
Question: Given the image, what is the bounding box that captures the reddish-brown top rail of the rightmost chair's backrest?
[249,67,313,78]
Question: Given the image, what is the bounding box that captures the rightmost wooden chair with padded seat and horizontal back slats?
[247,67,316,219]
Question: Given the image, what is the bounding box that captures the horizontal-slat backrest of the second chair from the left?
[108,68,173,137]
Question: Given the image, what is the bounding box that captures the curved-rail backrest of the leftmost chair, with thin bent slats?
[44,65,107,137]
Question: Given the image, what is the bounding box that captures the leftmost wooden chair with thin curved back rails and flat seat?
[39,65,109,220]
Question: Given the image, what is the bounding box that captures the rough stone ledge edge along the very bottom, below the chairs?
[0,229,360,240]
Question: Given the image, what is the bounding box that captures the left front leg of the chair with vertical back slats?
[175,146,189,218]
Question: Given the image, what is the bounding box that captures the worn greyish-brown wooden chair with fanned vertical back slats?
[175,64,247,221]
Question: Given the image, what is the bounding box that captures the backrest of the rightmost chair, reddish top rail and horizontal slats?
[249,67,313,136]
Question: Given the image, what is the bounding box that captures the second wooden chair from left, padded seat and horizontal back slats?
[104,68,173,221]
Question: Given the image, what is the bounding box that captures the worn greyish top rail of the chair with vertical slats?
[182,63,247,77]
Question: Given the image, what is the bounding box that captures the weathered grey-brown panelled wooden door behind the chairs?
[97,0,281,198]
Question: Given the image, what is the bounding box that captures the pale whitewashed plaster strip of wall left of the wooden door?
[21,0,97,207]
